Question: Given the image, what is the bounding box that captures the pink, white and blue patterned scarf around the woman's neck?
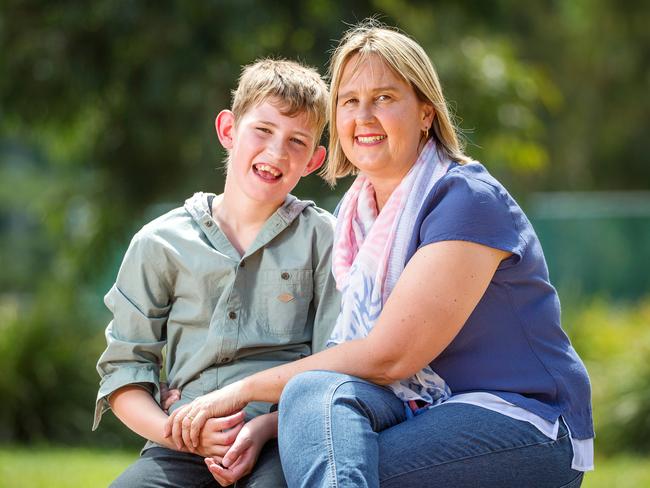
[328,139,451,410]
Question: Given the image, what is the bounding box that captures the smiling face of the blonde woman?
[336,55,433,180]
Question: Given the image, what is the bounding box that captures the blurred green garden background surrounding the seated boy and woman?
[0,0,650,486]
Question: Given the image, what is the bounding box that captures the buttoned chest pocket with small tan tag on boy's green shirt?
[262,269,314,338]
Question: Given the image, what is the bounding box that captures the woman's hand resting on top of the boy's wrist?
[163,381,248,451]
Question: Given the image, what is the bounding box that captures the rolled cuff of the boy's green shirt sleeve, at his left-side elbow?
[92,365,160,430]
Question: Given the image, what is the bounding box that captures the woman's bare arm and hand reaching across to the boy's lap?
[165,241,510,445]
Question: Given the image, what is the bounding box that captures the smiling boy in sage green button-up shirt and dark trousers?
[93,60,339,487]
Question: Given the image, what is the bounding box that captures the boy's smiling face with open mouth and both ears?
[215,100,325,206]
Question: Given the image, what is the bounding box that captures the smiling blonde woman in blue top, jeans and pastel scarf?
[168,23,594,487]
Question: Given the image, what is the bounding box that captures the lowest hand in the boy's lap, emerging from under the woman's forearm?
[205,413,278,486]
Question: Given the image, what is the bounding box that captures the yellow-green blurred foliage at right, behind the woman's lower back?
[563,299,650,455]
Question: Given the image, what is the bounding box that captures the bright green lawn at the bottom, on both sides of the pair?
[0,446,650,488]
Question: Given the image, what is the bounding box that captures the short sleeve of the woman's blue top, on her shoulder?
[418,165,525,261]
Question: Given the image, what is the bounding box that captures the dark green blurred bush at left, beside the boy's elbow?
[0,280,143,447]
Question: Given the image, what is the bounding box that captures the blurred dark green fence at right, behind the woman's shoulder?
[527,192,650,299]
